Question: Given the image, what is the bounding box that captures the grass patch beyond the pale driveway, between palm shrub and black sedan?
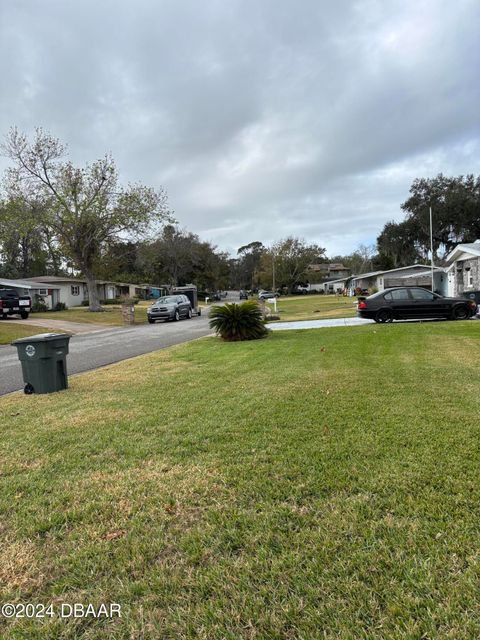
[268,294,357,322]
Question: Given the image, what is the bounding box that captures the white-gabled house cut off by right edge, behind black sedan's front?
[447,240,480,297]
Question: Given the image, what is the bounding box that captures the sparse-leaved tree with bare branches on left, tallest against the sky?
[4,128,170,311]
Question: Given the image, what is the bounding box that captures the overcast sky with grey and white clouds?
[0,0,480,256]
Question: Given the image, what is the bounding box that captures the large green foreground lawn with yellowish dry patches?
[0,321,480,640]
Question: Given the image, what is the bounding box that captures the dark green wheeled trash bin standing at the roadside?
[12,333,70,394]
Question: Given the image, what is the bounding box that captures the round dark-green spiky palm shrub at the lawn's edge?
[210,300,268,342]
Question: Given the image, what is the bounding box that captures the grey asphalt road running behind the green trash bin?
[0,315,212,395]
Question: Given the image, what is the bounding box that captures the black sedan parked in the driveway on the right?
[357,287,476,322]
